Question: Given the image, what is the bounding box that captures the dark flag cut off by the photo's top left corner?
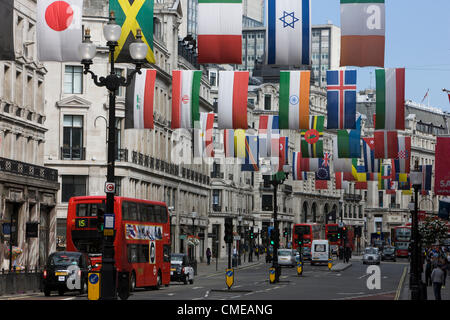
[0,0,16,61]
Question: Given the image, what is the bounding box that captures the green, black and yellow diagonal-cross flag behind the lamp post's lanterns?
[109,0,155,63]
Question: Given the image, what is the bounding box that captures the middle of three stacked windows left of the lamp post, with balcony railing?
[62,115,85,160]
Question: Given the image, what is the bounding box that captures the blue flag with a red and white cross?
[327,70,356,129]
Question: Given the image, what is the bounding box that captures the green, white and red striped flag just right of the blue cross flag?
[375,68,405,130]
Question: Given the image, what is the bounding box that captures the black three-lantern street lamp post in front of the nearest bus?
[79,12,148,300]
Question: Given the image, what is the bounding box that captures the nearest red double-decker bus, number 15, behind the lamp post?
[66,196,170,291]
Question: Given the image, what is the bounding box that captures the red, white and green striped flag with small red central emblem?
[172,70,202,129]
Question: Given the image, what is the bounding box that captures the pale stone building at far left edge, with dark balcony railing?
[0,0,59,269]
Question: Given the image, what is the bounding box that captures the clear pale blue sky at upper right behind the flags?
[311,0,450,112]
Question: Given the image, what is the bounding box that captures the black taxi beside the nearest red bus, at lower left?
[42,251,89,297]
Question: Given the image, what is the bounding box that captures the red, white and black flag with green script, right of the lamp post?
[125,69,156,129]
